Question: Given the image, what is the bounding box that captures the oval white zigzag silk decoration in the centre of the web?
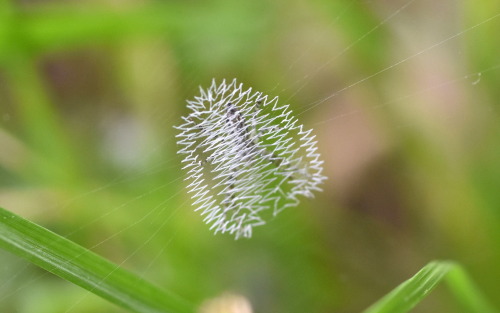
[176,80,326,239]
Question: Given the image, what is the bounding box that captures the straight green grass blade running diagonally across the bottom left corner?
[0,208,194,313]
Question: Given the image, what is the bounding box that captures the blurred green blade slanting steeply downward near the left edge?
[5,54,80,185]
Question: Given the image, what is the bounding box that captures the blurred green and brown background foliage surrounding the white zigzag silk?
[0,0,500,313]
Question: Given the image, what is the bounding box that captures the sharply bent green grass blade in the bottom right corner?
[363,261,497,313]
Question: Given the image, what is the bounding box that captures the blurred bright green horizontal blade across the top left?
[0,5,180,57]
